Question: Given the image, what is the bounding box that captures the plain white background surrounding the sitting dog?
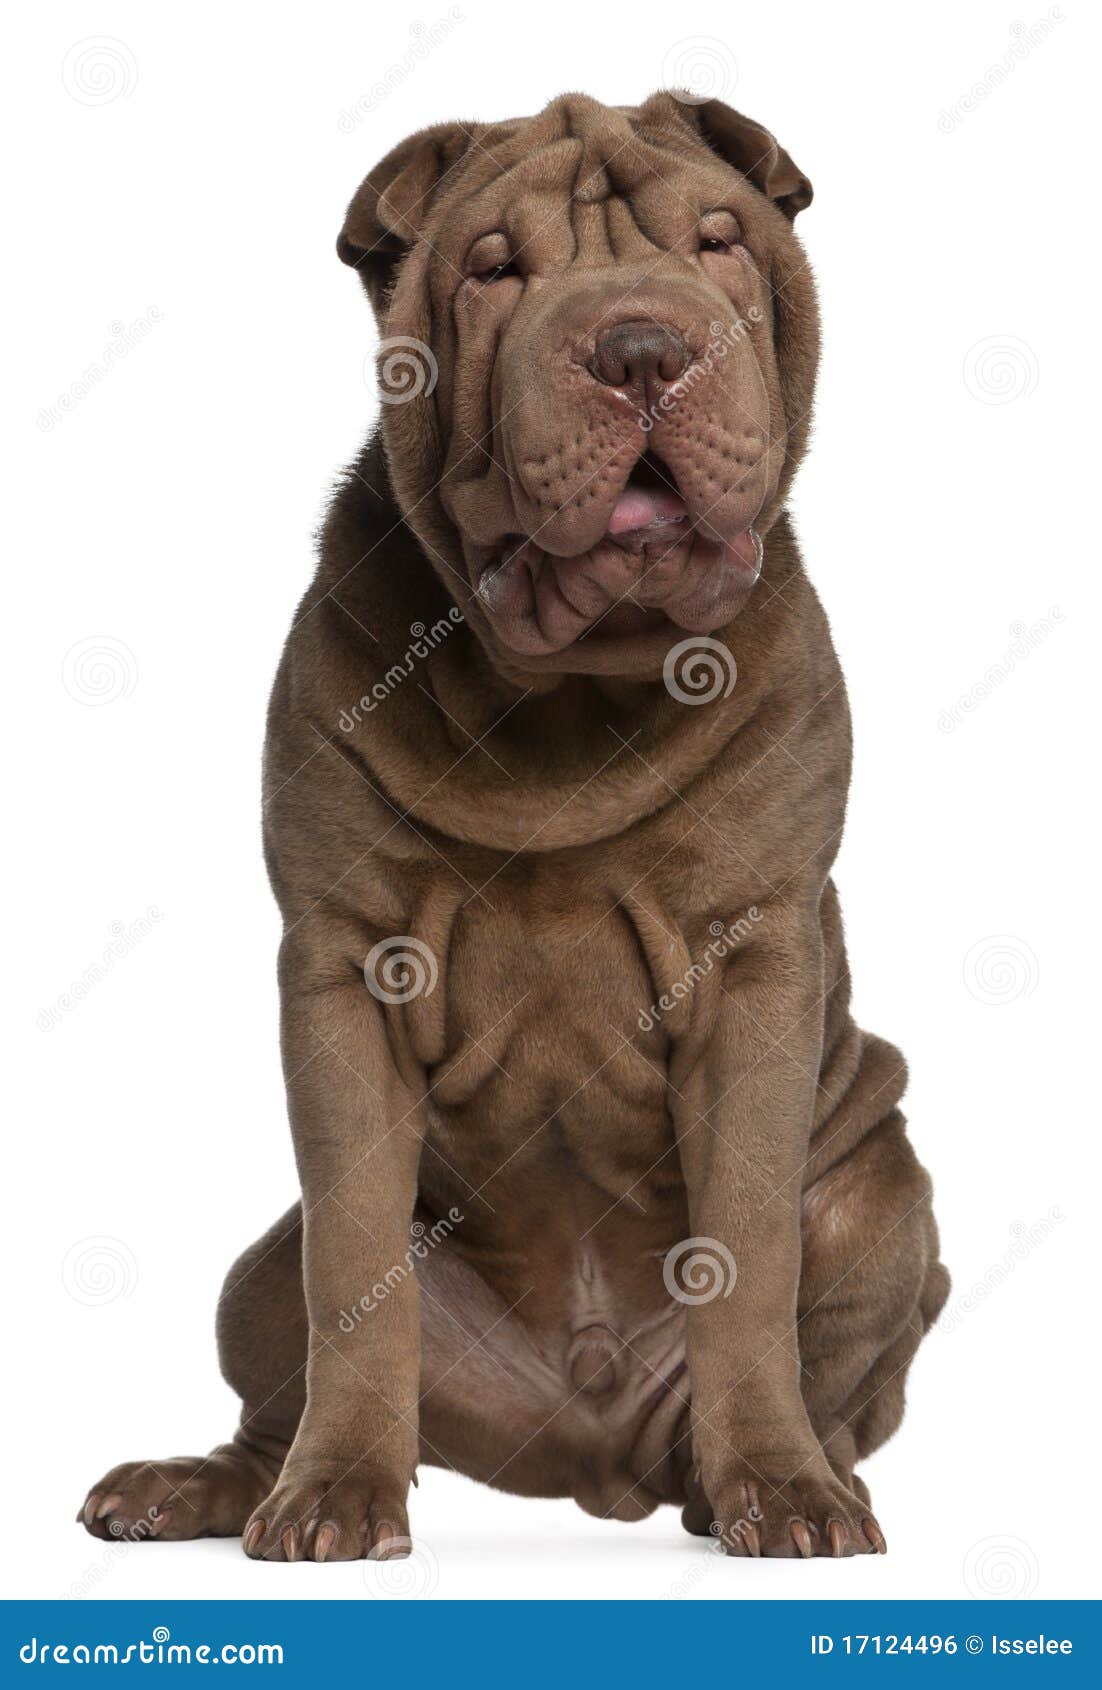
[0,0,1099,1599]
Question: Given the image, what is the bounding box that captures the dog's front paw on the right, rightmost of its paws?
[710,1475,887,1560]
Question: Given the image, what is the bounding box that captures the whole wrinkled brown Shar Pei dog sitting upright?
[81,95,948,1560]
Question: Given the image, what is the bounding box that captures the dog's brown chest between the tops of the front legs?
[422,875,673,1195]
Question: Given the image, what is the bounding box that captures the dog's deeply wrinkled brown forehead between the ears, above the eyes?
[424,96,752,272]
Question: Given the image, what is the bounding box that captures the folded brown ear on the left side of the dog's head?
[336,123,477,318]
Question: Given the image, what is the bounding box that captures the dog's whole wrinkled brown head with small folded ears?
[338,93,818,674]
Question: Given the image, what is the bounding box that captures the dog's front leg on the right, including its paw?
[674,906,879,1556]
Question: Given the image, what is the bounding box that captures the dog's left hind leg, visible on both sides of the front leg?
[79,1207,581,1541]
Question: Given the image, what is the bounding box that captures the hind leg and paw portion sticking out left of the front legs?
[78,1205,306,1543]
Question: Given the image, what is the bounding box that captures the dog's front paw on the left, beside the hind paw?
[243,1469,411,1562]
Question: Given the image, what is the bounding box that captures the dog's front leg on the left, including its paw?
[243,930,421,1562]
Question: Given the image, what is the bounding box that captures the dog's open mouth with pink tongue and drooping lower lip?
[477,451,762,656]
